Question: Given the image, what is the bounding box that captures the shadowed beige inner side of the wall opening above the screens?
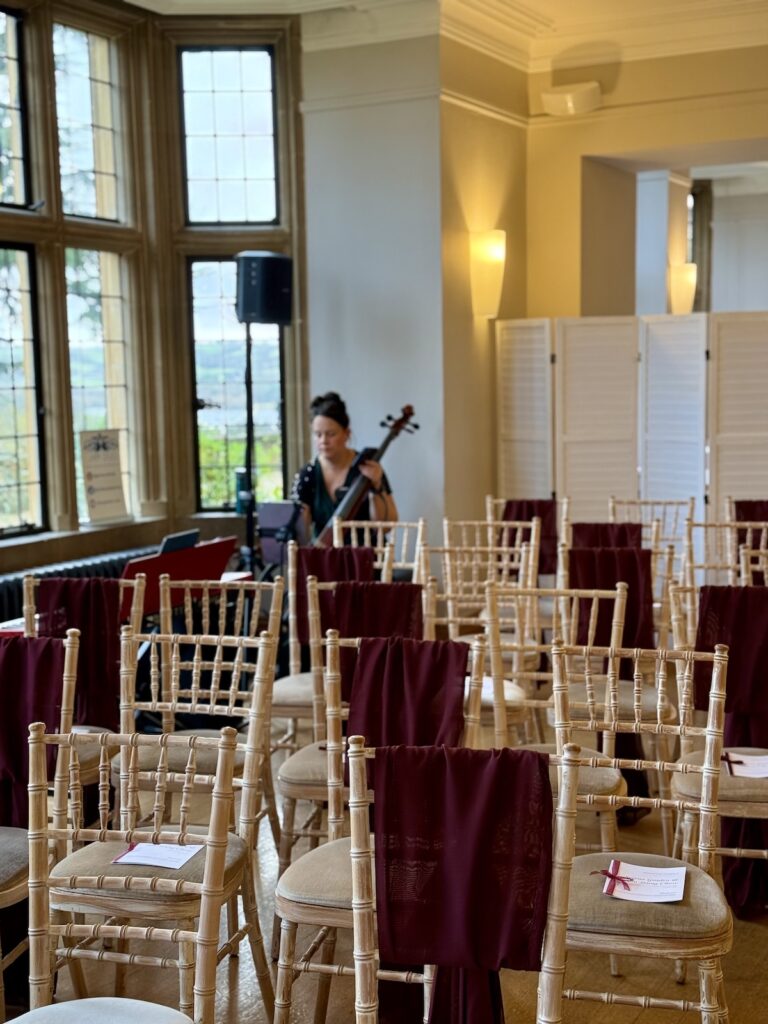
[582,160,636,316]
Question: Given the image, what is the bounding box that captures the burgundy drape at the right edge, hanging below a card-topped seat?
[694,587,768,916]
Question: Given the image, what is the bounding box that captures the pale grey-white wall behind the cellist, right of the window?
[303,39,444,524]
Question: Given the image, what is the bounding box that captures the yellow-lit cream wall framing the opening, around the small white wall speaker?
[526,47,768,316]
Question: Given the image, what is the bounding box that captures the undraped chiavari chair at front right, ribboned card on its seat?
[552,640,733,1024]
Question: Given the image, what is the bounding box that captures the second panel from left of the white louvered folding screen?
[555,316,638,521]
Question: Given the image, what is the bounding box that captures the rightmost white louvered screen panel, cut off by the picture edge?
[708,313,768,520]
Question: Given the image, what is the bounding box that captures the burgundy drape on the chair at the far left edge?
[0,637,65,828]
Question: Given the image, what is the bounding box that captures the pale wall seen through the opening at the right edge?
[712,189,768,312]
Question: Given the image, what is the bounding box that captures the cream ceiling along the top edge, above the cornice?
[133,0,768,71]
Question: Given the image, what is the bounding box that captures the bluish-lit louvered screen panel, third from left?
[638,313,707,507]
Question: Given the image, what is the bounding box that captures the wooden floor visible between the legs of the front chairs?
[34,724,768,1024]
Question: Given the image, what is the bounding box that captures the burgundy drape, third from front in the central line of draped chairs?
[332,582,424,700]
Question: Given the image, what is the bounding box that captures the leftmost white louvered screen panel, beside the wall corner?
[496,319,554,498]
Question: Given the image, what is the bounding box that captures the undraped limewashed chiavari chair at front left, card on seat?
[30,723,273,1024]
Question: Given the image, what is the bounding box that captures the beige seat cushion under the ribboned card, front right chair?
[568,852,731,939]
